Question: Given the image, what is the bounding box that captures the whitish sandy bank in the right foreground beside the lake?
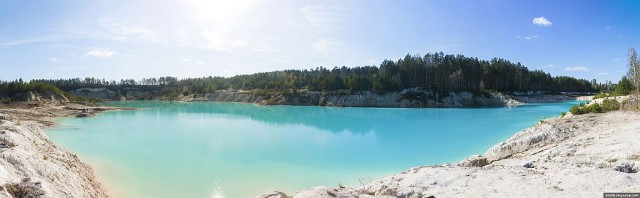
[258,111,640,198]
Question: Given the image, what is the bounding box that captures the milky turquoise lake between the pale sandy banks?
[47,101,577,198]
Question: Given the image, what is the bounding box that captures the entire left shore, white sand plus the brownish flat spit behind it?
[0,103,127,197]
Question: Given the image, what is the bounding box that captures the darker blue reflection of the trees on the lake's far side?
[111,102,524,133]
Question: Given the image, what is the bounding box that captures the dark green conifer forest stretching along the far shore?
[0,52,600,100]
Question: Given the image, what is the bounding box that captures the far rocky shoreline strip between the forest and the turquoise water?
[74,87,577,108]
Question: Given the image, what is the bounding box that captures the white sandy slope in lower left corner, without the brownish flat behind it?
[0,115,108,197]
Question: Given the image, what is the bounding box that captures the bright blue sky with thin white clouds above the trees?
[0,0,640,82]
